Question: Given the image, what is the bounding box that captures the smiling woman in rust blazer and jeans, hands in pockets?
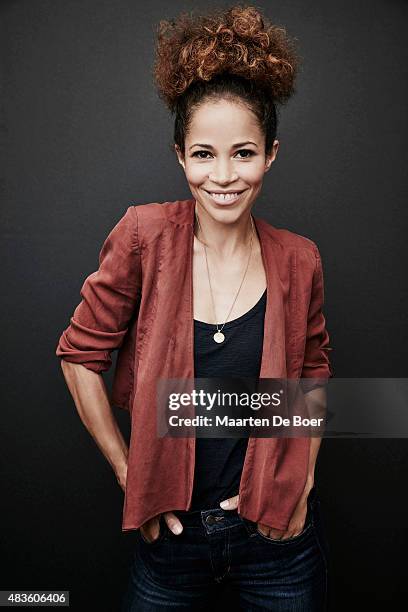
[57,6,332,610]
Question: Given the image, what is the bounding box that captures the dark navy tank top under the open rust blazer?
[189,289,266,511]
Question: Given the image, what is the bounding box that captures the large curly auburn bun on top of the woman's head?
[154,5,299,110]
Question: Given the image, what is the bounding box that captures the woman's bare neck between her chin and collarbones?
[194,201,255,257]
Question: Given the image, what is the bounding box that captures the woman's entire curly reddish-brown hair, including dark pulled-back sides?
[154,4,300,154]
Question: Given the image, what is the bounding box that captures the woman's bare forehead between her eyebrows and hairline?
[186,99,262,142]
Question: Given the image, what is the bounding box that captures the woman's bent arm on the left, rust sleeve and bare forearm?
[56,206,141,488]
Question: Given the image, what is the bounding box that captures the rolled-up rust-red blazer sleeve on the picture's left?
[56,206,141,372]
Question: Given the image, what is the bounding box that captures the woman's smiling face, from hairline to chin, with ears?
[175,100,279,223]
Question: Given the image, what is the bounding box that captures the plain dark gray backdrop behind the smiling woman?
[0,0,408,611]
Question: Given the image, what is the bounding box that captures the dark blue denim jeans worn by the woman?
[122,487,328,612]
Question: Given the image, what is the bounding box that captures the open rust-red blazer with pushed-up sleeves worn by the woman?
[56,199,333,531]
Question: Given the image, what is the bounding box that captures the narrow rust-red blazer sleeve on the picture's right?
[301,245,334,391]
